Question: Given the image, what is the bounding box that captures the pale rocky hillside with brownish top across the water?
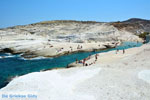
[0,19,149,56]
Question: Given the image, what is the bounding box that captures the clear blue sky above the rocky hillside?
[0,0,150,28]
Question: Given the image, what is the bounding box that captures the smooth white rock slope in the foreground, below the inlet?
[0,44,150,100]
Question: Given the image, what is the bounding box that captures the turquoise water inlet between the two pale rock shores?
[0,42,142,88]
